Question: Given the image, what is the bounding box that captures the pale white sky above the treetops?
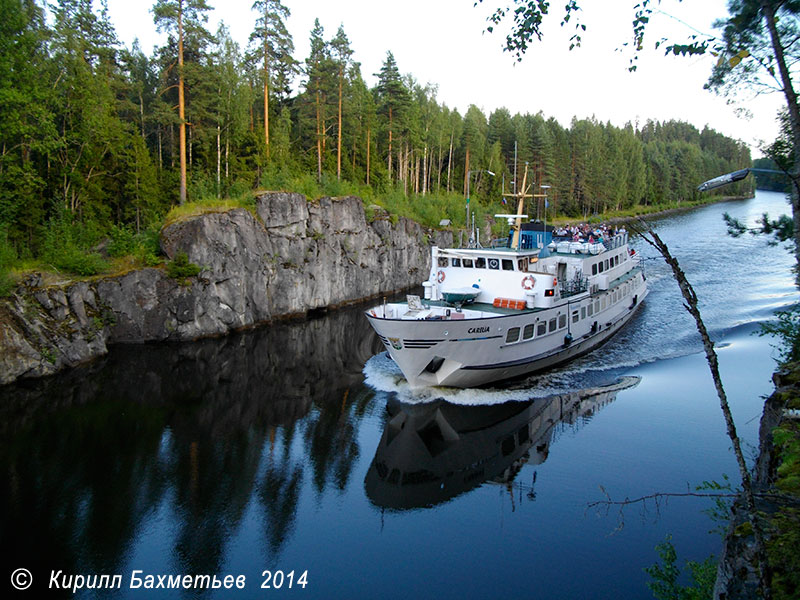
[103,0,783,157]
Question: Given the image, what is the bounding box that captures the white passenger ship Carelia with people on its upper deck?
[366,210,647,388]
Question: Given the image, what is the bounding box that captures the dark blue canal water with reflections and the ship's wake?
[0,193,797,599]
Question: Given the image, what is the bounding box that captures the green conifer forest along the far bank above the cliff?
[0,0,752,272]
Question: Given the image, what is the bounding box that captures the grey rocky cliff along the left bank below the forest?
[0,192,452,383]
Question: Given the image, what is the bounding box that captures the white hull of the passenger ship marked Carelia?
[367,279,647,388]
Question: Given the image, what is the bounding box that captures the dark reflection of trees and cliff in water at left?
[0,310,380,573]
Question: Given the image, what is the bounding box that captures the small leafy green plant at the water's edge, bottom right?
[645,536,717,600]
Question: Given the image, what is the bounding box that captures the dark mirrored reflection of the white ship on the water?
[364,377,640,510]
